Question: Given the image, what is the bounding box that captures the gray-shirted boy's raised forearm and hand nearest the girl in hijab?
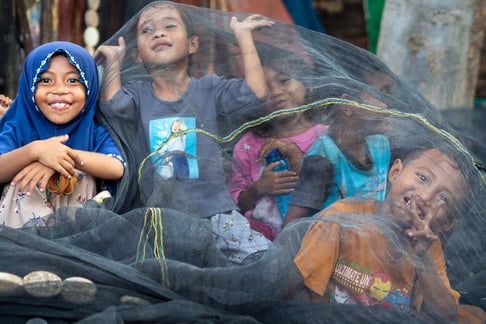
[94,37,125,100]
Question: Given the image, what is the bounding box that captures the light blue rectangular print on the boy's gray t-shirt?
[149,117,199,179]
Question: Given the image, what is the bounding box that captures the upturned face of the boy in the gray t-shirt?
[135,5,199,69]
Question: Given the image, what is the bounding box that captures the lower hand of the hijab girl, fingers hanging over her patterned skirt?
[11,162,55,196]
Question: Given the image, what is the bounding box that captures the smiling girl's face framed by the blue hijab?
[34,55,86,125]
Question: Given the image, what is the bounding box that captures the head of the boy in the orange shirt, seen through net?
[386,149,465,234]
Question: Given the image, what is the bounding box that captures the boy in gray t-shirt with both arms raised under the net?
[95,2,273,262]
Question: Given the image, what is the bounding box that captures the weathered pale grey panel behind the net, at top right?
[377,0,486,109]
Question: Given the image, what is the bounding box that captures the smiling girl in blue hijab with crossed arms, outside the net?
[0,42,124,227]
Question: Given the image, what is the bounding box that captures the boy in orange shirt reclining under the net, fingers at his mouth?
[160,148,486,321]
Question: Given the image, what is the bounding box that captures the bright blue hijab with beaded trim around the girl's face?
[0,41,100,154]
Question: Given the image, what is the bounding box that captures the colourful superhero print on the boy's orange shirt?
[331,259,411,311]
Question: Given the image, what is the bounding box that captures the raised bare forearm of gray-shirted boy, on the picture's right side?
[230,15,274,99]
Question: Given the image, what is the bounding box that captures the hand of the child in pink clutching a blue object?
[253,162,299,195]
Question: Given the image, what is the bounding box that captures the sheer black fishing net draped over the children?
[0,2,486,323]
